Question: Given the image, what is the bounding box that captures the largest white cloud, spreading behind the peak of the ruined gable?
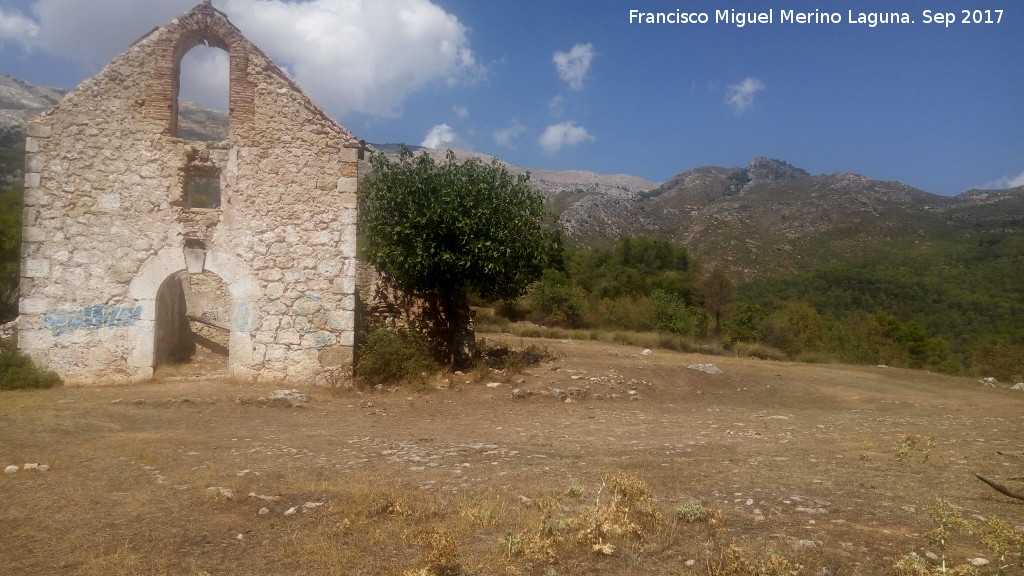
[0,0,484,117]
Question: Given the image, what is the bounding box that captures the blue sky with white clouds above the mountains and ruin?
[0,0,1024,195]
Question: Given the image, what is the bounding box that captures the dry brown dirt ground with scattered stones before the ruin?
[0,336,1024,576]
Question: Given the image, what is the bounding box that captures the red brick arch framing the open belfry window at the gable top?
[146,1,259,139]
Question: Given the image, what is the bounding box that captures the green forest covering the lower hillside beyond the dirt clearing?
[485,235,1024,381]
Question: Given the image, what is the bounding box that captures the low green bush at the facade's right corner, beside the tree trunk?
[355,328,437,386]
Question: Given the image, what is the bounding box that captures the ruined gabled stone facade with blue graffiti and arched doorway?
[18,2,360,384]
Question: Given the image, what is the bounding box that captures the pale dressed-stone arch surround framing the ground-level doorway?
[128,247,260,378]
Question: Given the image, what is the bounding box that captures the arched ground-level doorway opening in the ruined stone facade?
[154,271,231,376]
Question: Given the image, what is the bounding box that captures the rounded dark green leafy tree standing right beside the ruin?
[359,148,555,366]
